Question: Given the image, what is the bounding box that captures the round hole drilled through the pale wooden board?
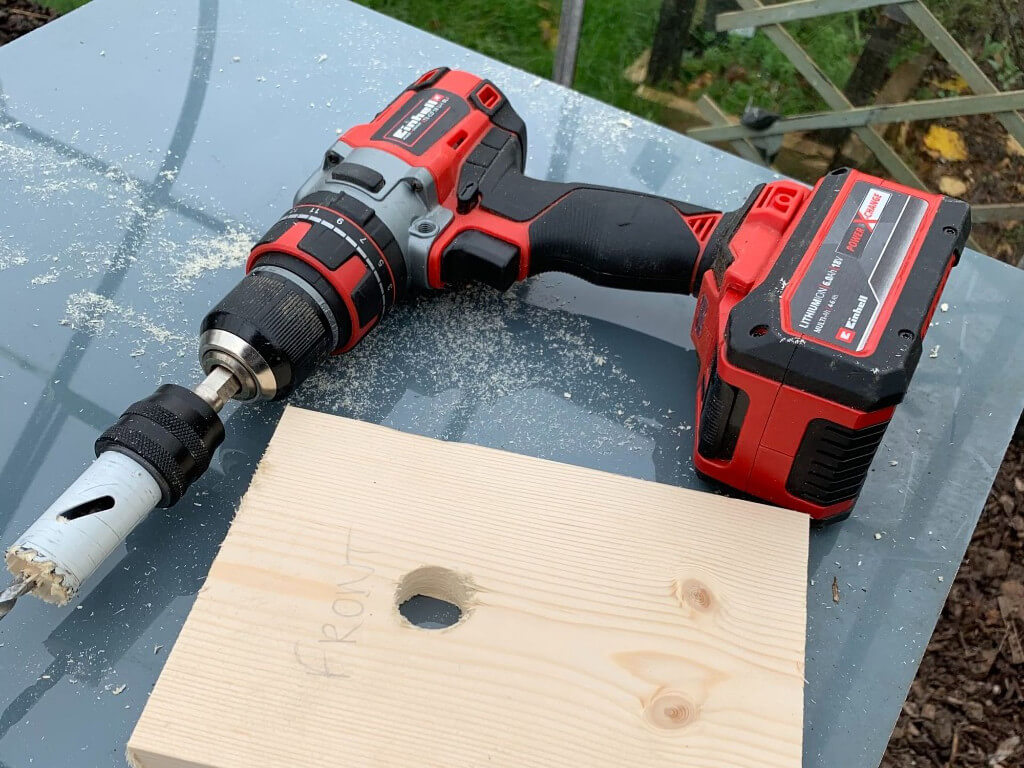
[394,565,475,630]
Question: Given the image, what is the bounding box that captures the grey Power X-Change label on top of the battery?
[788,181,928,351]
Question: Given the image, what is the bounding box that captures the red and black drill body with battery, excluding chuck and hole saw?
[230,68,970,519]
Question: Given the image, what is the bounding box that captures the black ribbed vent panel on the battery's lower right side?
[785,419,889,507]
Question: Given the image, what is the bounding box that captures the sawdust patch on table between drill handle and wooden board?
[293,286,627,419]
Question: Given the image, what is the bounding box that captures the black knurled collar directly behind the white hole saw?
[95,384,224,507]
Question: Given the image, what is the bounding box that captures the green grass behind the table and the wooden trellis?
[42,0,970,118]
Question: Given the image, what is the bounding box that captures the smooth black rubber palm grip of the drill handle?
[524,185,703,294]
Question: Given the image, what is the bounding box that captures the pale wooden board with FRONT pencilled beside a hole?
[128,408,808,768]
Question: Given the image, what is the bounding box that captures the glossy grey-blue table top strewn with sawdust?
[0,0,1024,768]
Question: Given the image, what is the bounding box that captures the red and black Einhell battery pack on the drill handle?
[691,169,971,519]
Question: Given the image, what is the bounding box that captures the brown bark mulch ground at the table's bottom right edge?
[882,439,1024,768]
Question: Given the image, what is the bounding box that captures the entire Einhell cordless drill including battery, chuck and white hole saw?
[0,68,970,615]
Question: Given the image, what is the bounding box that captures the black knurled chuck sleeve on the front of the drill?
[202,271,334,399]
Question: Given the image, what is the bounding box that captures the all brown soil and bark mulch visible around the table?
[6,0,1024,768]
